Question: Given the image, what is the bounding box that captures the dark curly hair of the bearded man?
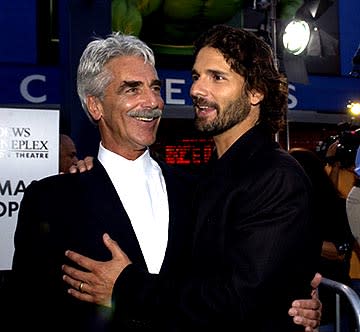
[194,25,288,133]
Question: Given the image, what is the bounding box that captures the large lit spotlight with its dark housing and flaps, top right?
[278,0,338,84]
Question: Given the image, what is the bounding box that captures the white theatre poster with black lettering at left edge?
[0,108,59,271]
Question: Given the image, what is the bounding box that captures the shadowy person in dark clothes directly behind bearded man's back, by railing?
[289,147,354,332]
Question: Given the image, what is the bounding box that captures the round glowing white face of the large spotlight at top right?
[282,19,310,55]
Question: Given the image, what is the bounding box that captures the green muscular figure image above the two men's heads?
[112,0,303,53]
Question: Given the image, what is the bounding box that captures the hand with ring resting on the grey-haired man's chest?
[62,234,131,307]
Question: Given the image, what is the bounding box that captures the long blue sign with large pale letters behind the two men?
[0,66,360,113]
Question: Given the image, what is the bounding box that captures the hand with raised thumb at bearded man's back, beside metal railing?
[289,273,322,332]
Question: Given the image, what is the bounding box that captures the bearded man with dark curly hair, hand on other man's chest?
[63,26,321,332]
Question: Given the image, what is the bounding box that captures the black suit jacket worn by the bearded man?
[114,125,321,332]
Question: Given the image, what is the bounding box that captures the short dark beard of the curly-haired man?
[195,94,251,136]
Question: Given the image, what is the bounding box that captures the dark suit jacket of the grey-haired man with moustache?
[10,160,192,332]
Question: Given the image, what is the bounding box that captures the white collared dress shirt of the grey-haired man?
[98,143,169,273]
